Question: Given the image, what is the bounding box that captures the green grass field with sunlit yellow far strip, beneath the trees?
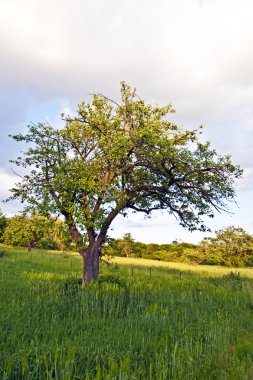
[0,246,253,380]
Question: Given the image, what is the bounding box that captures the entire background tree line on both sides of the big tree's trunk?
[0,211,253,267]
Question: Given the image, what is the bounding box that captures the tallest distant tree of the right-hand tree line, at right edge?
[200,226,253,266]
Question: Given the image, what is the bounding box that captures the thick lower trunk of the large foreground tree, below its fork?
[82,243,101,285]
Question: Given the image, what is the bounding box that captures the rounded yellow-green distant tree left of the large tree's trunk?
[3,213,70,251]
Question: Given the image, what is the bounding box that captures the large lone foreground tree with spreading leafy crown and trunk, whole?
[7,82,242,284]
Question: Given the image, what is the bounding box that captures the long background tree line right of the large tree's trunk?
[104,226,253,267]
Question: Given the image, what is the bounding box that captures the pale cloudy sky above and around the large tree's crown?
[0,0,253,243]
